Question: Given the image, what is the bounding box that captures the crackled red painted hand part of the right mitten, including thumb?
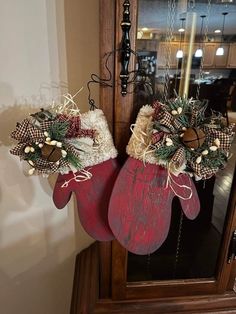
[108,157,200,255]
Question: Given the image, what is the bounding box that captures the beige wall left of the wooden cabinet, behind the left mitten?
[0,0,99,314]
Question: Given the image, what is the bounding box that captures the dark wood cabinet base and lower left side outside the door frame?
[70,243,236,314]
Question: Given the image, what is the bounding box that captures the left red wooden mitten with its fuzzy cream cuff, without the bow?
[53,109,119,241]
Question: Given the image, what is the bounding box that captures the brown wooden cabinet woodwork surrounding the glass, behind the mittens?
[70,0,236,314]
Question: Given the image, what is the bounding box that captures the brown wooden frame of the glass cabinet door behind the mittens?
[101,0,236,300]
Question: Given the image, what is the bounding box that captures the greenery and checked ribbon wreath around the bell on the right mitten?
[153,97,234,176]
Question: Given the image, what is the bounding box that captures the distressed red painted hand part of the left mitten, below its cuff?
[53,159,119,241]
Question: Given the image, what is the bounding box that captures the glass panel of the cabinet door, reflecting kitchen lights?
[127,0,236,282]
